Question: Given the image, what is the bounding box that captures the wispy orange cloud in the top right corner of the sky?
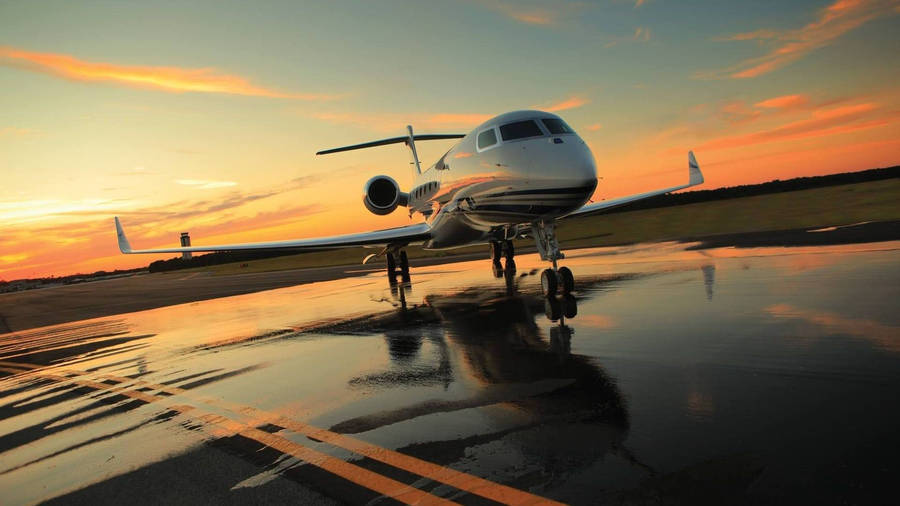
[694,0,897,79]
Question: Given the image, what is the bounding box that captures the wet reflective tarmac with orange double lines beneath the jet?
[0,242,900,504]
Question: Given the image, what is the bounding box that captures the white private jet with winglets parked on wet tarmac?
[115,110,703,297]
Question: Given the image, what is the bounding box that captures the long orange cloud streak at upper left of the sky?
[0,47,334,100]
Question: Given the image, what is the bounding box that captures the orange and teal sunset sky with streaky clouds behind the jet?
[0,0,900,280]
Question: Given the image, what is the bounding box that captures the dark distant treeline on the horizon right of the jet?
[596,165,900,213]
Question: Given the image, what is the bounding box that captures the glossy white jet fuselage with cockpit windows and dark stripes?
[408,111,597,249]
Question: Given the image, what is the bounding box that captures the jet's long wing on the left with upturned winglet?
[115,216,431,254]
